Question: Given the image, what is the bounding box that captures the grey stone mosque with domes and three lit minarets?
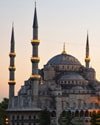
[7,2,100,125]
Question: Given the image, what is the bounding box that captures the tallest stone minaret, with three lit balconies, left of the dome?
[31,3,40,96]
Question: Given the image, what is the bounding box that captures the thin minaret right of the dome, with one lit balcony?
[85,33,90,68]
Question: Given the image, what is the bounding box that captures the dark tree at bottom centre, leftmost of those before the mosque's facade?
[40,109,50,125]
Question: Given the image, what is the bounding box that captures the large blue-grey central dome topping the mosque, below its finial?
[47,53,81,66]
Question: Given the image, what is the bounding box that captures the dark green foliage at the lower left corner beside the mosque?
[0,98,8,125]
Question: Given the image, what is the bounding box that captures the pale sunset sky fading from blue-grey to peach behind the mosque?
[0,0,100,100]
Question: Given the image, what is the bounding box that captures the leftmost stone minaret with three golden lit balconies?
[8,25,16,99]
